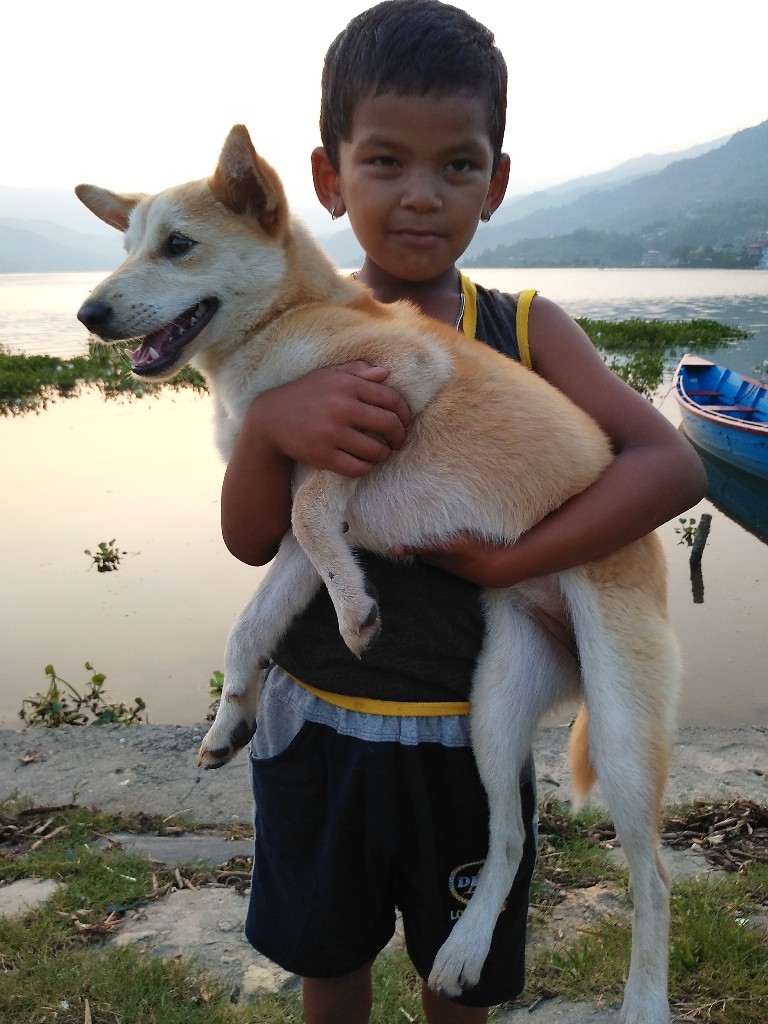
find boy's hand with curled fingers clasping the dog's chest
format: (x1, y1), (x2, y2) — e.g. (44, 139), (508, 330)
(257, 361), (412, 477)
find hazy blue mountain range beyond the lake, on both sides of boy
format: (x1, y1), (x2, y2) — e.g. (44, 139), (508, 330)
(0, 121), (768, 273)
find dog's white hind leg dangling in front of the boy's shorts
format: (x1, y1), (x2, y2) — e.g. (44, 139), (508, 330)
(429, 590), (579, 996)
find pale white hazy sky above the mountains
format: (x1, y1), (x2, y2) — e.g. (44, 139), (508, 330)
(7, 0), (768, 207)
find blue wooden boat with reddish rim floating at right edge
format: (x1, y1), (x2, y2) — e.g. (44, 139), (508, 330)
(675, 355), (768, 478)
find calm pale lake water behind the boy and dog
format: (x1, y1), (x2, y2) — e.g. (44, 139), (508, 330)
(0, 269), (768, 727)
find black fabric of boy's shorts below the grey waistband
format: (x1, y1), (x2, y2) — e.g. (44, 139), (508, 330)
(246, 722), (536, 1007)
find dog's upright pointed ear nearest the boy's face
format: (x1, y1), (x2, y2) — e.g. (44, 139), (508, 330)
(208, 125), (288, 236)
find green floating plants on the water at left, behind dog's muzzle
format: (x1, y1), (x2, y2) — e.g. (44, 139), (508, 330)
(0, 342), (207, 416)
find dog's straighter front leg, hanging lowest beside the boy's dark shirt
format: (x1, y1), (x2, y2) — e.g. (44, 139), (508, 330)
(198, 532), (321, 768)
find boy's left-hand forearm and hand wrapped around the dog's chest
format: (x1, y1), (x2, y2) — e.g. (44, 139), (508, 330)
(221, 362), (411, 565)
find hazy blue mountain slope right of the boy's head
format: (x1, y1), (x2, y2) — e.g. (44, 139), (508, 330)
(465, 121), (768, 266)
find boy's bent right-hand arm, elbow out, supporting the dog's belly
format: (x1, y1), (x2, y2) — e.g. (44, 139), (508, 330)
(403, 298), (707, 587)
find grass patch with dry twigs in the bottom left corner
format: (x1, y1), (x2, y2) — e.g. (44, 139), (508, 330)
(0, 804), (237, 1024)
